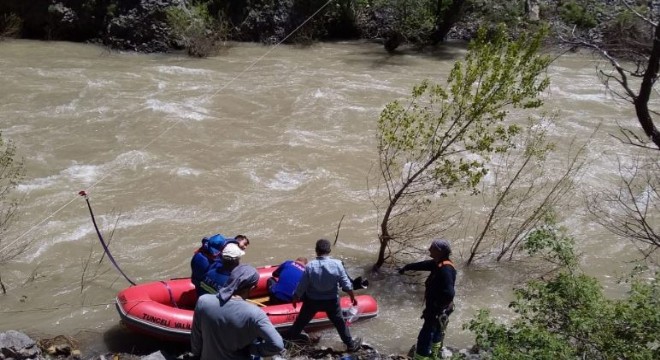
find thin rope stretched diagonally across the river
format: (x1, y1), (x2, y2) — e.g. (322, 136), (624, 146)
(0, 0), (334, 272)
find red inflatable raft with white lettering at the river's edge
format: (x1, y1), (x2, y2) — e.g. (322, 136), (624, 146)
(116, 266), (378, 342)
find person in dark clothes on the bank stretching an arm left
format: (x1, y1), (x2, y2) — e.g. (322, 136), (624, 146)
(399, 239), (456, 360)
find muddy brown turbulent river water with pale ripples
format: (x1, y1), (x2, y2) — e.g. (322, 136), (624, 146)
(0, 41), (652, 353)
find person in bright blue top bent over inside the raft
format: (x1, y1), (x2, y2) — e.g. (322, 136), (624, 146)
(267, 257), (307, 304)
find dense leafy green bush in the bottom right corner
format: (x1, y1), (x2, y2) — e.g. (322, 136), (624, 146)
(465, 221), (660, 360)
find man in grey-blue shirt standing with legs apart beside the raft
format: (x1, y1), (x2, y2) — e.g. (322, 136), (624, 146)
(286, 239), (362, 351)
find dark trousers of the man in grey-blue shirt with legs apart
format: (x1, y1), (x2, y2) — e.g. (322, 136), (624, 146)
(286, 297), (353, 346)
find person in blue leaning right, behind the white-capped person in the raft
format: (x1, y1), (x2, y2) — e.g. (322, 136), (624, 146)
(190, 234), (250, 296)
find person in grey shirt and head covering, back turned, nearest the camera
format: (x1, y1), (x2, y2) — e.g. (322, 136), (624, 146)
(190, 265), (284, 360)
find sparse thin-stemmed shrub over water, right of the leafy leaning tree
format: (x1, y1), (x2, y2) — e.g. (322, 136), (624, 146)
(467, 118), (586, 265)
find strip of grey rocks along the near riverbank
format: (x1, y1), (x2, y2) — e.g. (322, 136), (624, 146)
(0, 330), (482, 360)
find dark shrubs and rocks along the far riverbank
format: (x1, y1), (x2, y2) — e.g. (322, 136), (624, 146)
(0, 0), (648, 57)
